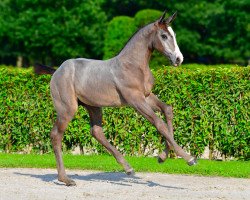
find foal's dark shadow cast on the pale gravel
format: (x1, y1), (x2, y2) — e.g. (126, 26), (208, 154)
(14, 172), (186, 190)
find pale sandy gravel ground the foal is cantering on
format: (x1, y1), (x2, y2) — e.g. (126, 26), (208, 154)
(0, 168), (250, 200)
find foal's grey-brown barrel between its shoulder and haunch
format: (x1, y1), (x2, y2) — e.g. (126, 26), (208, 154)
(74, 62), (123, 107)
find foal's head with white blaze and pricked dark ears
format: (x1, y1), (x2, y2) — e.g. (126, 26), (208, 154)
(153, 11), (183, 67)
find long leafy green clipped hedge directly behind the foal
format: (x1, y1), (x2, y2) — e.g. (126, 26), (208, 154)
(0, 67), (250, 160)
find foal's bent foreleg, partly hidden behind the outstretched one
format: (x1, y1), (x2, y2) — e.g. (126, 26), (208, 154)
(146, 93), (174, 163)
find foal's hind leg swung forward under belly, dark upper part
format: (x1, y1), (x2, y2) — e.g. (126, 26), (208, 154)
(85, 106), (134, 175)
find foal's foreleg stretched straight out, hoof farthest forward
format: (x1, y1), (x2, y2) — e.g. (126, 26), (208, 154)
(127, 92), (196, 165)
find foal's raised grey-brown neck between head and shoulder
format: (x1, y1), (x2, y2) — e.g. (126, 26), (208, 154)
(118, 25), (152, 68)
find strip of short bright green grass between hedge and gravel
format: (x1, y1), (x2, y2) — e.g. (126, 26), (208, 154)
(0, 153), (250, 178)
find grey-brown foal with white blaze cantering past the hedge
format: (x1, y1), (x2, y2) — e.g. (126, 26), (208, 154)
(50, 12), (196, 186)
